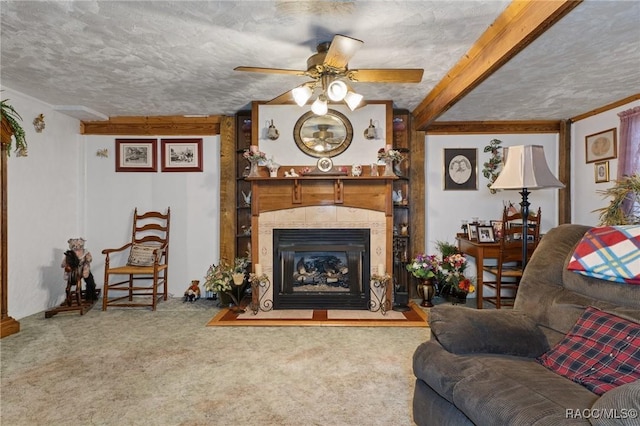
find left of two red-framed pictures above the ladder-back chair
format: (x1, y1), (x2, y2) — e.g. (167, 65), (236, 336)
(116, 139), (158, 172)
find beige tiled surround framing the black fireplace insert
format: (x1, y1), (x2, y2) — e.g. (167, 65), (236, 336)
(257, 205), (387, 308)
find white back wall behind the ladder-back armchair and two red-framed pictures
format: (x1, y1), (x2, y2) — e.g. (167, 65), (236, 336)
(82, 135), (220, 297)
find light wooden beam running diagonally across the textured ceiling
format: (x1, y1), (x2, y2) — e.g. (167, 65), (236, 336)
(413, 0), (582, 131)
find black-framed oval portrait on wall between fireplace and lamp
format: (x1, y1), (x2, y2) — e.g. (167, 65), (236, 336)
(442, 148), (478, 191)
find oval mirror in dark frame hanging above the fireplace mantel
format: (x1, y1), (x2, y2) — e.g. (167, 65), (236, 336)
(293, 109), (353, 158)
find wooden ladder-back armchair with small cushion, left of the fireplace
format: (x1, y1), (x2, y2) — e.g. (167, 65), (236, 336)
(102, 208), (171, 311)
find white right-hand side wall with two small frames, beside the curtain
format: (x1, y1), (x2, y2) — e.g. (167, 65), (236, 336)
(571, 101), (640, 226)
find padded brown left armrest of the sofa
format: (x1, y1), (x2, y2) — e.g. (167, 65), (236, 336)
(429, 305), (549, 358)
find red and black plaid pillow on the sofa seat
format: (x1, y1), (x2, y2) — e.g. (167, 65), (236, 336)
(537, 306), (640, 395)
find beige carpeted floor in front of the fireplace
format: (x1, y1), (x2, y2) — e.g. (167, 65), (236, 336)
(0, 299), (429, 425)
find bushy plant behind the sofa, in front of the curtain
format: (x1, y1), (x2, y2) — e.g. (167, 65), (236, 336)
(594, 173), (640, 226)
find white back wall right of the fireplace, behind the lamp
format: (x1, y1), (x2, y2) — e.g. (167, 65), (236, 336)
(424, 134), (558, 296)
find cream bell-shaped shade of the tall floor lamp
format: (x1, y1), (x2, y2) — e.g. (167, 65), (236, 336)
(491, 145), (564, 189)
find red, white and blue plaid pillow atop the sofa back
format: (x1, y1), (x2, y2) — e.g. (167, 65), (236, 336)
(567, 225), (640, 284)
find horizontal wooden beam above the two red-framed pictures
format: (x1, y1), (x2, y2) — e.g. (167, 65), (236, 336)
(80, 115), (223, 136)
